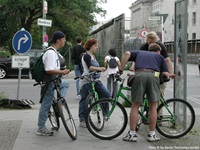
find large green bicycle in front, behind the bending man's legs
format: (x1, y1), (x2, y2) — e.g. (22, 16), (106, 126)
(86, 75), (195, 140)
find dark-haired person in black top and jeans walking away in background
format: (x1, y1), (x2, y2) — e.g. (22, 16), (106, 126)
(71, 37), (85, 100)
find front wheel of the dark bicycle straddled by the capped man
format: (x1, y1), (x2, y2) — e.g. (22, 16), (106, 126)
(58, 98), (77, 140)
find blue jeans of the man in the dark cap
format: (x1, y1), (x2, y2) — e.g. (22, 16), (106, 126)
(38, 80), (69, 129)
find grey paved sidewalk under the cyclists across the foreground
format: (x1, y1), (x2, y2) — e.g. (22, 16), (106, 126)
(0, 104), (200, 150)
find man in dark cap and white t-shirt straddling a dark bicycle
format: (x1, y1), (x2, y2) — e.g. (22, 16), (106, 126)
(36, 31), (70, 136)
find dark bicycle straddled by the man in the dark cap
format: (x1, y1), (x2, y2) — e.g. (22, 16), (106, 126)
(34, 75), (77, 140)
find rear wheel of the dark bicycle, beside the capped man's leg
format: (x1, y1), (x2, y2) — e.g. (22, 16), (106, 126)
(48, 102), (60, 130)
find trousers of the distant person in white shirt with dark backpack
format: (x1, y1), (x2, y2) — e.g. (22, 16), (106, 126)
(107, 74), (118, 97)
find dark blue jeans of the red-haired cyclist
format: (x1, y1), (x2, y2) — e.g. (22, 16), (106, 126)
(79, 81), (110, 122)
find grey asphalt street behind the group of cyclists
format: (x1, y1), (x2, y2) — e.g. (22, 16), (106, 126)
(0, 64), (200, 108)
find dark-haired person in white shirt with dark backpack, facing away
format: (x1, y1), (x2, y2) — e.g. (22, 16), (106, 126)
(104, 48), (121, 97)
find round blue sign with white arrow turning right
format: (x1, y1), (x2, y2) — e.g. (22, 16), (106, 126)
(12, 28), (32, 54)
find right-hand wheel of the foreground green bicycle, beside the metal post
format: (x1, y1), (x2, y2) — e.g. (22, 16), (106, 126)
(156, 98), (195, 138)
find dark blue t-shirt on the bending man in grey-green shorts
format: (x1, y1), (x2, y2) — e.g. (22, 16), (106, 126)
(129, 51), (169, 72)
